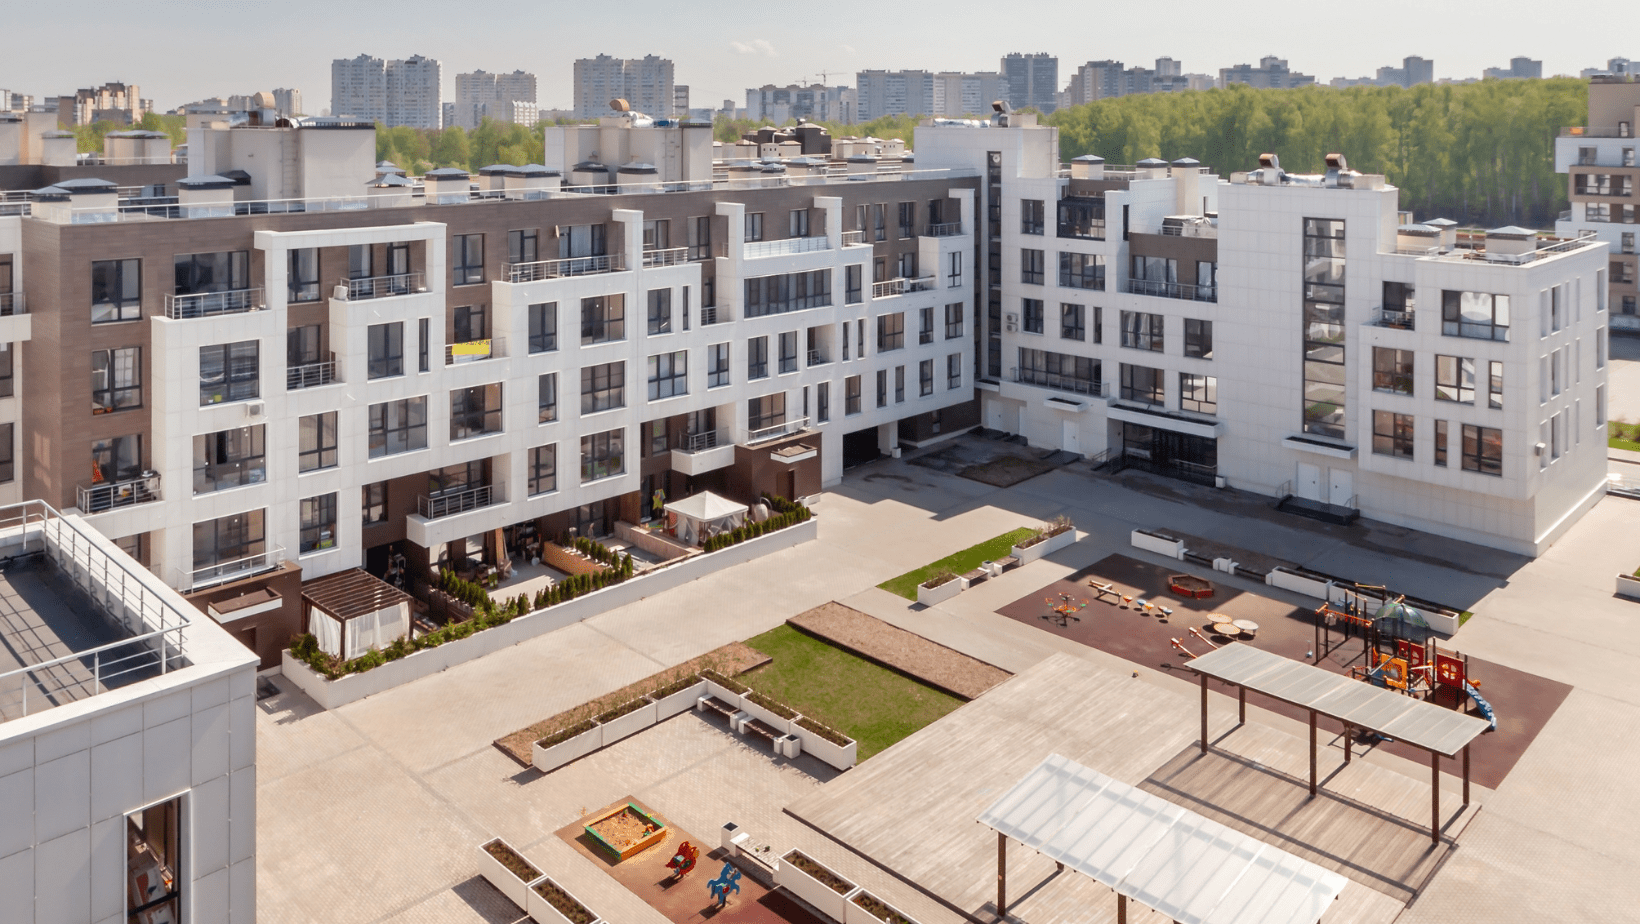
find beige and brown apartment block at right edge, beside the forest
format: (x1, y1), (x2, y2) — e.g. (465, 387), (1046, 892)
(1555, 75), (1640, 330)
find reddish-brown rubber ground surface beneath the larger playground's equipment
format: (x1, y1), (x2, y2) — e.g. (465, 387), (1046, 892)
(997, 555), (1571, 789)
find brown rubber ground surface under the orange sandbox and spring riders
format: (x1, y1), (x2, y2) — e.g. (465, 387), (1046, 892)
(554, 796), (827, 924)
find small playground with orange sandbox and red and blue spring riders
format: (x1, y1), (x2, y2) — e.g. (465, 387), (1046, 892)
(554, 796), (827, 924)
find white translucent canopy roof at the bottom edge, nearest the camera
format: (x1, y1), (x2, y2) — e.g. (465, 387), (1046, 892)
(977, 755), (1346, 924)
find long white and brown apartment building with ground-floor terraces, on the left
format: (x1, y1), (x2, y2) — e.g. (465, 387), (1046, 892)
(0, 113), (977, 666)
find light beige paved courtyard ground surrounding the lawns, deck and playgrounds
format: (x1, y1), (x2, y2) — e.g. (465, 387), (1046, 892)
(257, 416), (1640, 924)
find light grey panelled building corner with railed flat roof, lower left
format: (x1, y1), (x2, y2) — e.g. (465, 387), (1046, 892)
(0, 501), (256, 924)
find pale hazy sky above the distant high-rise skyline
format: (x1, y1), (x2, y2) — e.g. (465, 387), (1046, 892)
(0, 0), (1640, 115)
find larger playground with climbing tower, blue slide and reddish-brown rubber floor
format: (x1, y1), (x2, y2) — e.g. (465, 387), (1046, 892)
(997, 555), (1571, 788)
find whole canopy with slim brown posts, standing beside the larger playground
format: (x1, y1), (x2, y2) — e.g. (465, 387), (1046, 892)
(1186, 642), (1489, 844)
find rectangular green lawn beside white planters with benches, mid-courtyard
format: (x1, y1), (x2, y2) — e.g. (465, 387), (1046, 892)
(738, 625), (963, 760)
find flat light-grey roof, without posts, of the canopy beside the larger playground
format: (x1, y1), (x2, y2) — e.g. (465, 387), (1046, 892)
(1186, 642), (1491, 757)
